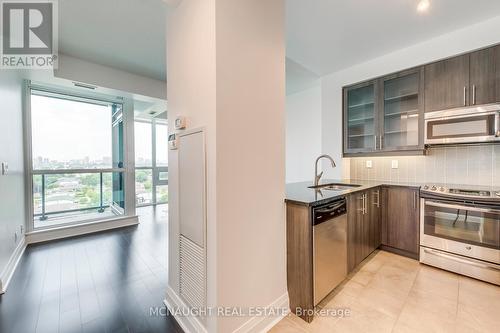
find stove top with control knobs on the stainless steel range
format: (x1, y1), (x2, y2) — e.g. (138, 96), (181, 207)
(421, 184), (500, 200)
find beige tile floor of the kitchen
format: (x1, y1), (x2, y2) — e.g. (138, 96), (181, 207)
(270, 251), (500, 333)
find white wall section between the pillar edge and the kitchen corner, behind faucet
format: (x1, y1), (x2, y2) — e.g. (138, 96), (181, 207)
(286, 82), (322, 183)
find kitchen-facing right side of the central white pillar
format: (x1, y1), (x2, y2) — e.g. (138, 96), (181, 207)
(216, 0), (287, 332)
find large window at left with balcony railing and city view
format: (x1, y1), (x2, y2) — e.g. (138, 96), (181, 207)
(30, 89), (124, 228)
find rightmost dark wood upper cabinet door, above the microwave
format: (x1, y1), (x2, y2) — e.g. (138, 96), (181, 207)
(469, 46), (500, 105)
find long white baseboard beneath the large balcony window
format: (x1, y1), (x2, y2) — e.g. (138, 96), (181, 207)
(26, 216), (139, 244)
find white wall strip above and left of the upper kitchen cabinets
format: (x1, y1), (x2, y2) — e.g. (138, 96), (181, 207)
(322, 16), (500, 178)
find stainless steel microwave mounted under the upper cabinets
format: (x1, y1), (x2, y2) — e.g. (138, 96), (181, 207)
(424, 104), (500, 145)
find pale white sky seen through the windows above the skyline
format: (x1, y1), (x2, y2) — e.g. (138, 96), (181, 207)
(31, 95), (168, 165)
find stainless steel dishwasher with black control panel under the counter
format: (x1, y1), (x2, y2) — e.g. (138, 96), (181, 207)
(313, 198), (347, 306)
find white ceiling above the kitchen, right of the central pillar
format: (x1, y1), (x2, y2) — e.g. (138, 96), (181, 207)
(286, 0), (500, 75)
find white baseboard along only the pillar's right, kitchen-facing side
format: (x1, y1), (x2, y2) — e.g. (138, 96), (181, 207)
(233, 292), (290, 333)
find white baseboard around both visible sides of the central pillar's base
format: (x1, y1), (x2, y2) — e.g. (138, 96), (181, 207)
(164, 286), (290, 333)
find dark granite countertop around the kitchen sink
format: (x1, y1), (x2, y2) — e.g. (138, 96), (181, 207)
(285, 179), (423, 206)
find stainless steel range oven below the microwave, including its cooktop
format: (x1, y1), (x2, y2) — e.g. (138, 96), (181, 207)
(420, 186), (500, 285)
